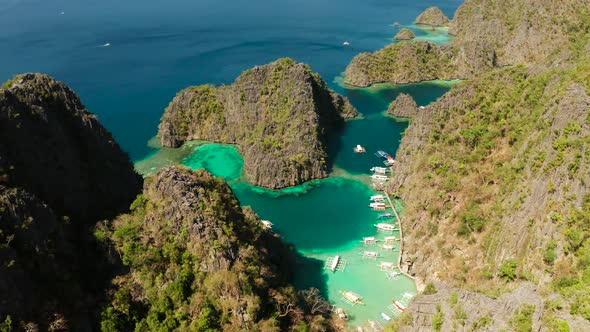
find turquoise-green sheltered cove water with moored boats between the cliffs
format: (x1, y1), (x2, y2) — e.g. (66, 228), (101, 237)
(136, 80), (452, 326)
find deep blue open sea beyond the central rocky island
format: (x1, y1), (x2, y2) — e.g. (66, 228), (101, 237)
(0, 0), (461, 160)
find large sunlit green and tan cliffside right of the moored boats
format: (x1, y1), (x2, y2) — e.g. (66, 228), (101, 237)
(389, 59), (590, 330)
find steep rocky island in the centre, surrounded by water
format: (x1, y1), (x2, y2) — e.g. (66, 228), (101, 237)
(158, 59), (357, 189)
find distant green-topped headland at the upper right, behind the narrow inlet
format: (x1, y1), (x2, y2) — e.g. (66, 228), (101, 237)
(345, 0), (590, 86)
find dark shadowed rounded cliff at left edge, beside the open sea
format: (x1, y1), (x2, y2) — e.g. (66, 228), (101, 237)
(0, 74), (141, 223)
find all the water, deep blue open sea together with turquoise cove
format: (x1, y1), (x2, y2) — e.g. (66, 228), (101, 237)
(0, 0), (462, 325)
